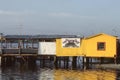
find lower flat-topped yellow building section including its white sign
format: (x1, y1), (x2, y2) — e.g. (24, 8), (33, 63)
(56, 38), (83, 56)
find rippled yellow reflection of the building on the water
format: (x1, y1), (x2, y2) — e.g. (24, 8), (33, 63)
(55, 70), (116, 80)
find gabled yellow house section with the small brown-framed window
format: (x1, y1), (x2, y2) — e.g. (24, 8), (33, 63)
(83, 33), (116, 57)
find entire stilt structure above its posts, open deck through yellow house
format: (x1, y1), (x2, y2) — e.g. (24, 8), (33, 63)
(1, 33), (117, 57)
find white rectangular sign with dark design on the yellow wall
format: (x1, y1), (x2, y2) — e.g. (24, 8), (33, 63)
(62, 38), (80, 48)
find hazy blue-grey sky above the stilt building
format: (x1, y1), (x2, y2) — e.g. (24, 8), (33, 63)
(0, 0), (120, 35)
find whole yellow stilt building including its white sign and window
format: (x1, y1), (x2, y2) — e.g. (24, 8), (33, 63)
(56, 33), (116, 57)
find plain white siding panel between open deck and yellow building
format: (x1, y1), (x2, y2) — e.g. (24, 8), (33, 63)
(38, 42), (56, 55)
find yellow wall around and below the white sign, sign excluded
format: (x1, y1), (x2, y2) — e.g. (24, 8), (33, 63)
(56, 39), (83, 56)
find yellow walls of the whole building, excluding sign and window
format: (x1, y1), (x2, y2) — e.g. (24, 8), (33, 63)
(56, 34), (116, 57)
